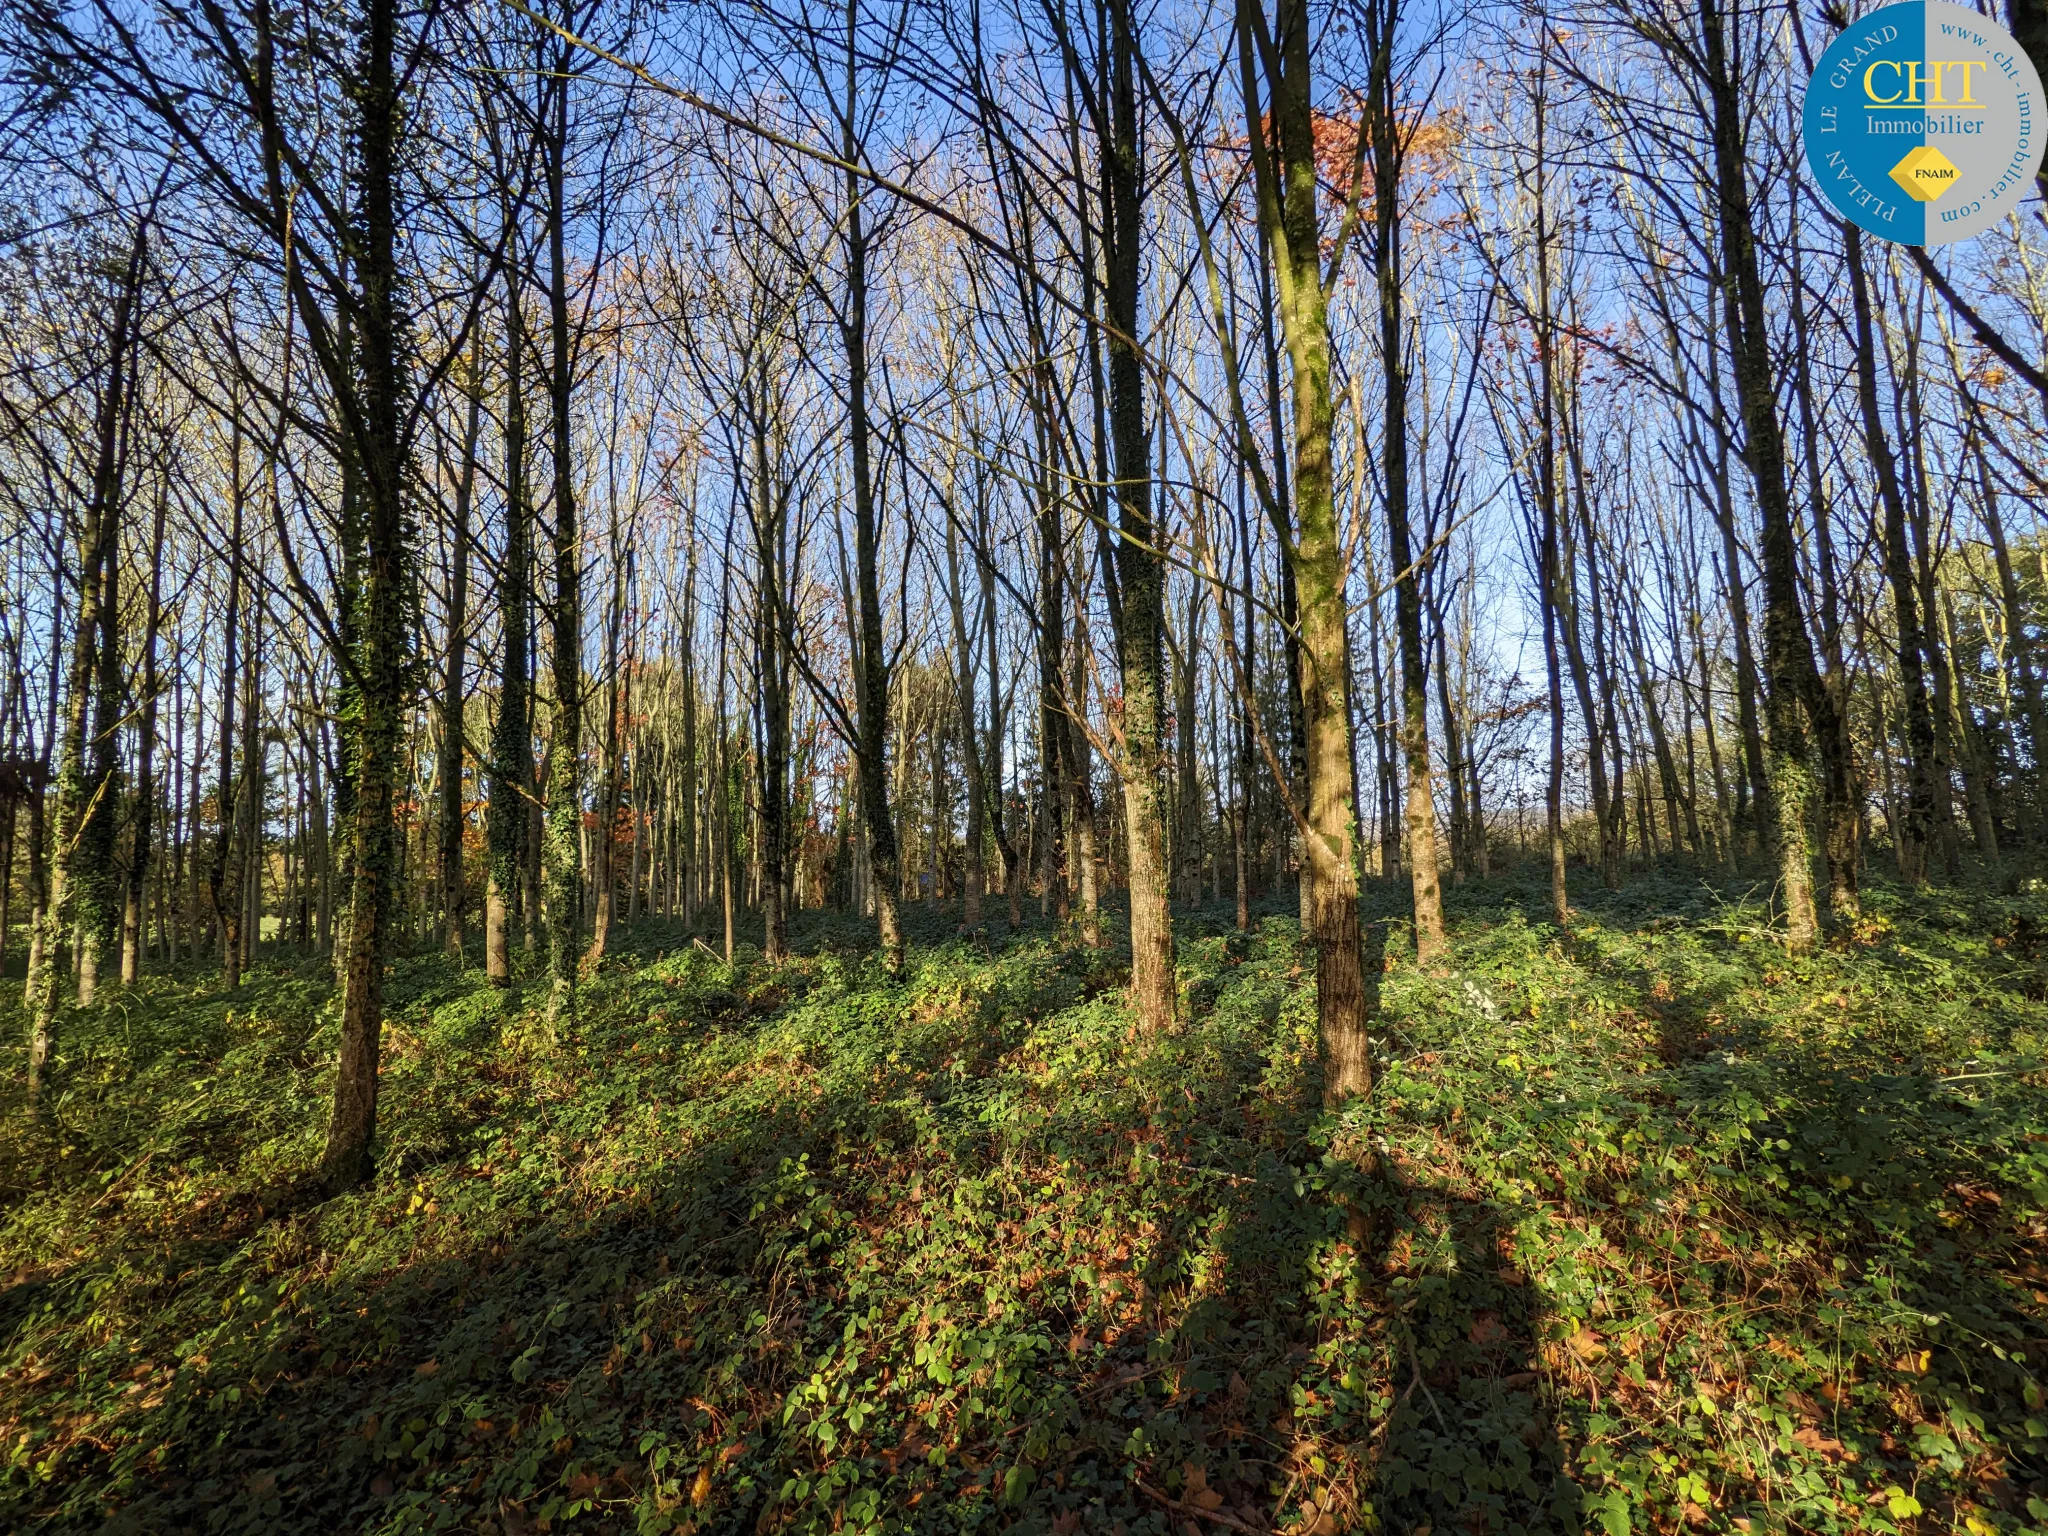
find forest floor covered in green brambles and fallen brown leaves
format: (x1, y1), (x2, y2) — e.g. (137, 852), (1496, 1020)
(0, 868), (2048, 1536)
